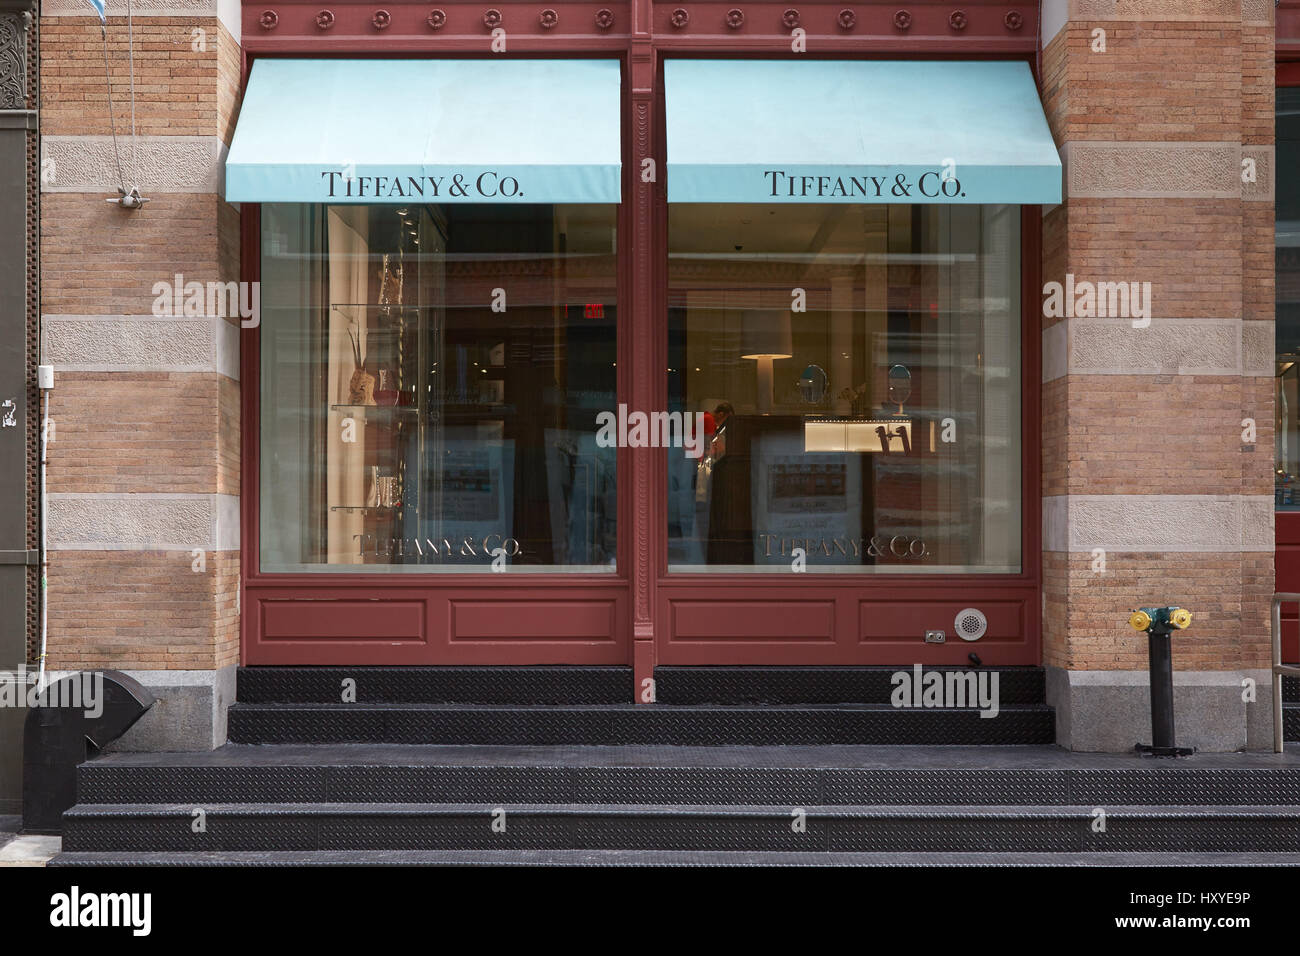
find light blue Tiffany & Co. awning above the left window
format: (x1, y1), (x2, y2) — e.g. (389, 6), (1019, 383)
(226, 60), (621, 203)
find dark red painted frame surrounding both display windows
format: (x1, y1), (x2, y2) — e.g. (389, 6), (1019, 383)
(241, 0), (1043, 684)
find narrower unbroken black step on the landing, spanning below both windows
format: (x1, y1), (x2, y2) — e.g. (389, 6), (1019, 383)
(229, 704), (1056, 745)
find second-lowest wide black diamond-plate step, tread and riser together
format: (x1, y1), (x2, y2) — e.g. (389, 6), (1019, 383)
(62, 804), (1300, 853)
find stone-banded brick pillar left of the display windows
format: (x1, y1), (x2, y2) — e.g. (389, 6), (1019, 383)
(40, 5), (242, 671)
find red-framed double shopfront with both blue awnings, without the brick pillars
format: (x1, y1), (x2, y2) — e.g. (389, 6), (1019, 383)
(228, 46), (1060, 679)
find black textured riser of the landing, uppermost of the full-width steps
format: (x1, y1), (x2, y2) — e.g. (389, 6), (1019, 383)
(78, 763), (1300, 806)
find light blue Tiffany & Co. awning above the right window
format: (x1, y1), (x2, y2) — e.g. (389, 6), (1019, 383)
(664, 60), (1061, 204)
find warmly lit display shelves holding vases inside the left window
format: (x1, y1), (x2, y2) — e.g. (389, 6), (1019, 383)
(324, 207), (446, 564)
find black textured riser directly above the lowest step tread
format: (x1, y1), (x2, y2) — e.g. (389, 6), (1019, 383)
(64, 809), (1300, 852)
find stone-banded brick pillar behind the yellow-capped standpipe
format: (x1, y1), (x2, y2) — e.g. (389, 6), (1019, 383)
(1043, 0), (1273, 671)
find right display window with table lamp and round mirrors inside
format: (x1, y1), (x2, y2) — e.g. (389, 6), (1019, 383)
(667, 203), (1023, 574)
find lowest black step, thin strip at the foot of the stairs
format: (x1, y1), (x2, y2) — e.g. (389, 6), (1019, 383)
(49, 849), (1300, 868)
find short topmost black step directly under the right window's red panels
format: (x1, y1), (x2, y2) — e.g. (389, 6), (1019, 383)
(654, 666), (1047, 704)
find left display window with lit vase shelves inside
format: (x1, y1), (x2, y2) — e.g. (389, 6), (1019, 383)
(260, 203), (618, 572)
